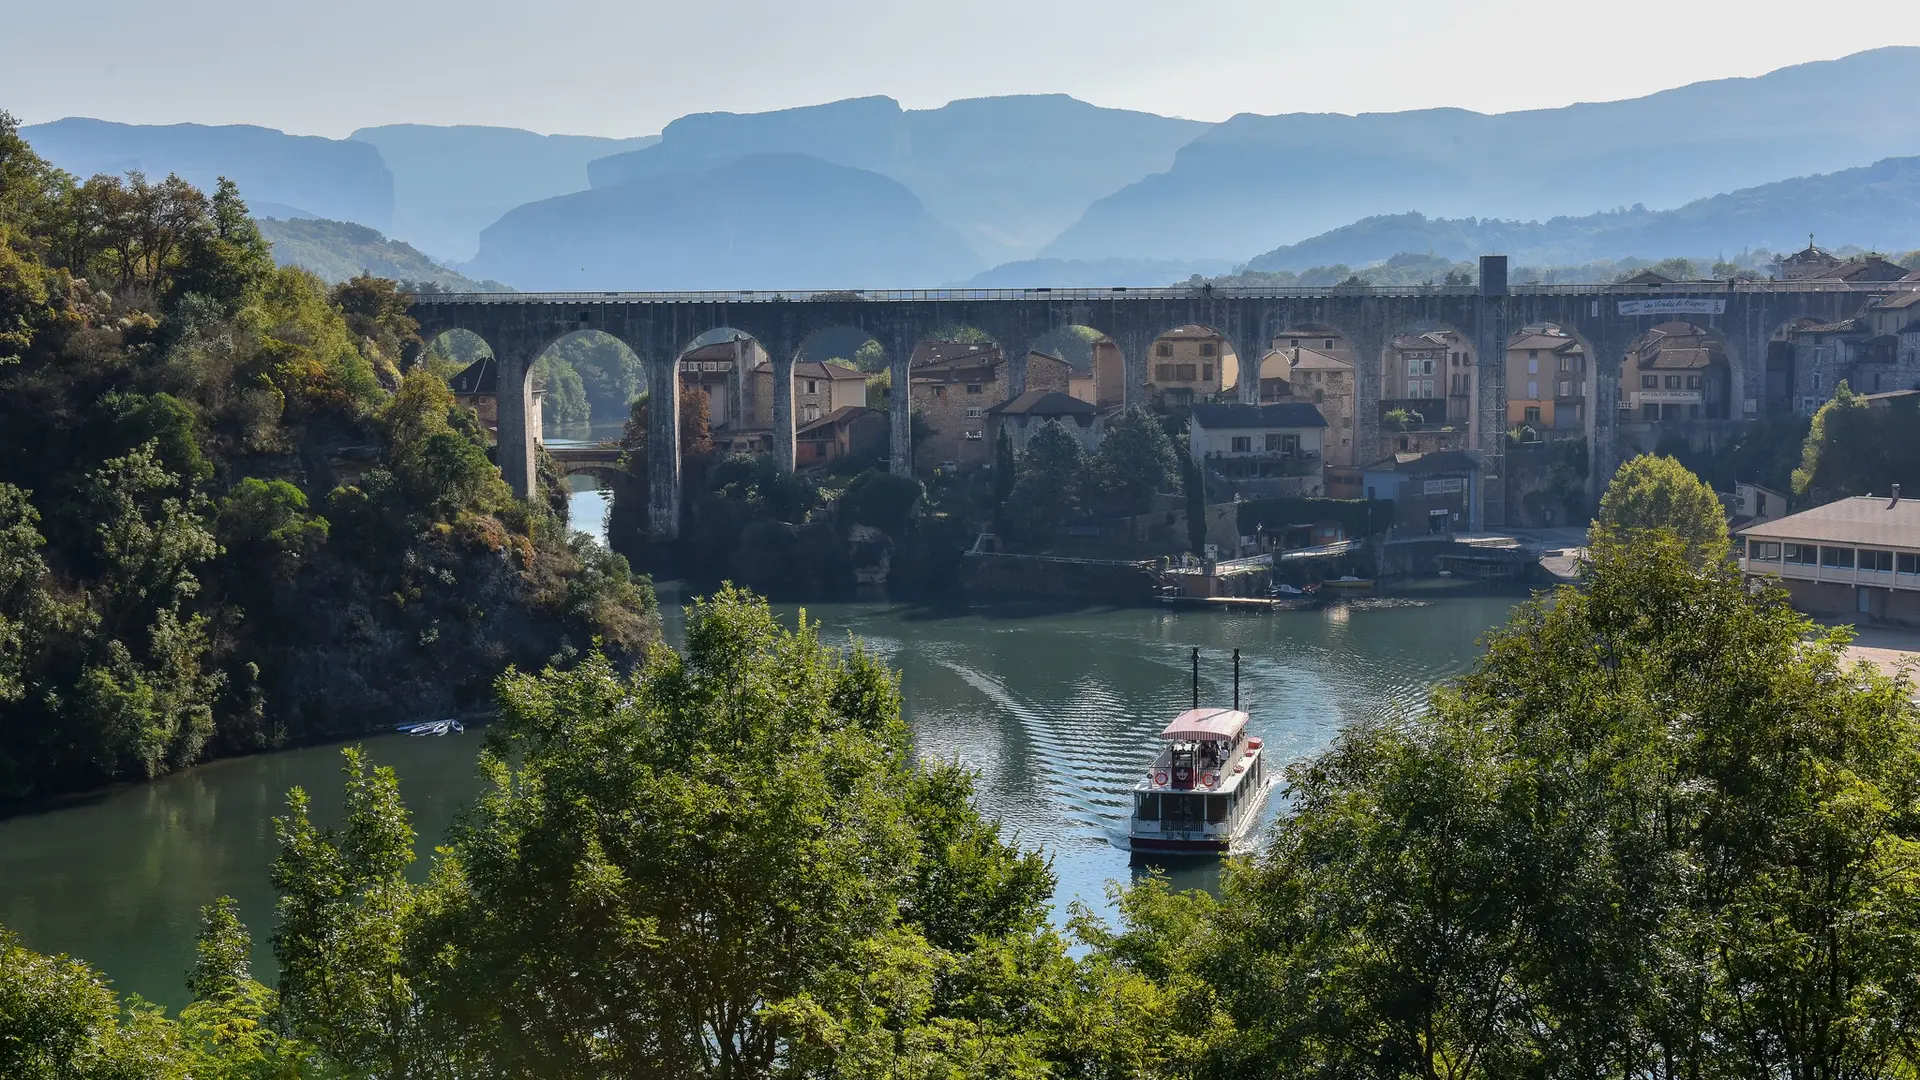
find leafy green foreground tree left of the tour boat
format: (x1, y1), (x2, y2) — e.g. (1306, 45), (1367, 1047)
(259, 588), (1073, 1080)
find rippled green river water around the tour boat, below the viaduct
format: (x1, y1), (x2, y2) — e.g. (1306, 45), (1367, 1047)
(0, 484), (1517, 1007)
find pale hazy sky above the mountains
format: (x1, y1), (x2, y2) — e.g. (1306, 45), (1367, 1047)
(11, 0), (1920, 136)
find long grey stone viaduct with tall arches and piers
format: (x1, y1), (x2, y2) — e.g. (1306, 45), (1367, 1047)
(409, 256), (1920, 540)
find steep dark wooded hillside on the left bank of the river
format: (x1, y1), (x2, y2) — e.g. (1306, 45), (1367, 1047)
(0, 113), (655, 798)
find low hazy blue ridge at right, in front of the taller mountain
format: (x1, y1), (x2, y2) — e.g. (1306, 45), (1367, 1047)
(1246, 158), (1920, 271)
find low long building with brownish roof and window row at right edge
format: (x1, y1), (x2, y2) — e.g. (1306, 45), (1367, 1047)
(1736, 484), (1920, 625)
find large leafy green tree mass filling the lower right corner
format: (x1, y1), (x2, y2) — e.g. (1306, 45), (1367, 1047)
(1136, 528), (1920, 1078)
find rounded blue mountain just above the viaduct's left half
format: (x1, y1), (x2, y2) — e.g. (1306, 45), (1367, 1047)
(463, 154), (979, 290)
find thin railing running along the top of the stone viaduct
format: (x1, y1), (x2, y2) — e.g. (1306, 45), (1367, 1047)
(413, 281), (1920, 306)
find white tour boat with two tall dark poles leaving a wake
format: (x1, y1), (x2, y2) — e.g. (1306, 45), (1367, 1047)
(1127, 650), (1275, 855)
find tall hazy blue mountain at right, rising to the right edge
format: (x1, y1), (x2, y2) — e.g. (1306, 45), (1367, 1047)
(1043, 48), (1920, 259)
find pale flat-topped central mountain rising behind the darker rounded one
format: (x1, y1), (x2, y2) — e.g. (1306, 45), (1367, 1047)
(588, 94), (1206, 263)
